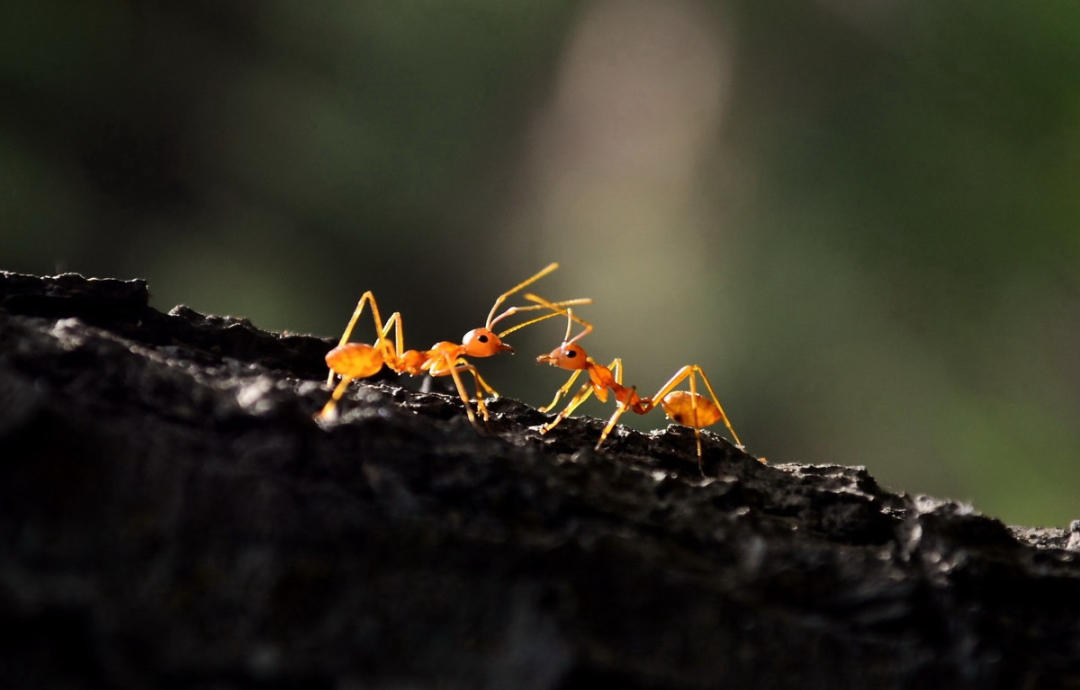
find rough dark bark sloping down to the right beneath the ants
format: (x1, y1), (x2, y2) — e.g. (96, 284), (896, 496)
(0, 273), (1080, 690)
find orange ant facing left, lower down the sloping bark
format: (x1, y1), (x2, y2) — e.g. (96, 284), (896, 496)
(525, 294), (744, 471)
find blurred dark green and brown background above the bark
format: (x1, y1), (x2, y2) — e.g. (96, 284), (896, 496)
(0, 0), (1080, 526)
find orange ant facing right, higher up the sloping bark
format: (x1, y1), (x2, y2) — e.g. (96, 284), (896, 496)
(316, 263), (592, 429)
